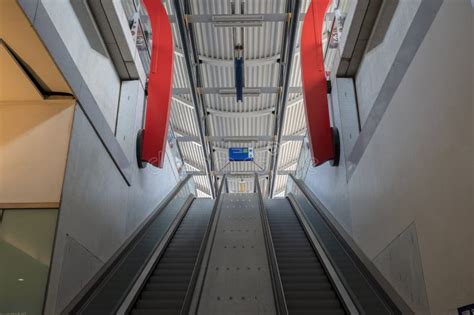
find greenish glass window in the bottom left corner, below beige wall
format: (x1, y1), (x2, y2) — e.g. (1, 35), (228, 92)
(0, 209), (58, 315)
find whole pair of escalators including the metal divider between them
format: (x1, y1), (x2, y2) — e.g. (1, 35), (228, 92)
(72, 176), (412, 315)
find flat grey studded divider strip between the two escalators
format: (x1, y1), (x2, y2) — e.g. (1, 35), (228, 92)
(198, 194), (276, 315)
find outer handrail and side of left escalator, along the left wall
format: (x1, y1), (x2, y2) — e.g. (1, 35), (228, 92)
(67, 175), (193, 314)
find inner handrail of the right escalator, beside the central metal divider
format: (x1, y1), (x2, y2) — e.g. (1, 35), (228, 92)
(255, 174), (288, 315)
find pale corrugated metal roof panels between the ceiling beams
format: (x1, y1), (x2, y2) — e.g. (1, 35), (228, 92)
(164, 0), (309, 196)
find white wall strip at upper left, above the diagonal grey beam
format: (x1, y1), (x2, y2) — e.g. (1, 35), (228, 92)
(41, 0), (120, 131)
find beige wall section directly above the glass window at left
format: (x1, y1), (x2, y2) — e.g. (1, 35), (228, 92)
(0, 100), (75, 207)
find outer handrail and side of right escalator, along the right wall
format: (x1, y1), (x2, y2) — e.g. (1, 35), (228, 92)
(289, 174), (414, 314)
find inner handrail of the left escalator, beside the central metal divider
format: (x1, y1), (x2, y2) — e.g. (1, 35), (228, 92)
(180, 175), (226, 315)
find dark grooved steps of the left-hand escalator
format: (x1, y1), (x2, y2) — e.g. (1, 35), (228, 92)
(131, 199), (212, 314)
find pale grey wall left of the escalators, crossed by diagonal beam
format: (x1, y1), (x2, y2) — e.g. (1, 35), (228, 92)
(45, 81), (179, 314)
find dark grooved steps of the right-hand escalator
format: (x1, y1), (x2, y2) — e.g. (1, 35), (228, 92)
(265, 199), (346, 315)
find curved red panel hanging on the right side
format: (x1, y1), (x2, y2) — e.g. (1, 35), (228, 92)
(301, 0), (335, 165)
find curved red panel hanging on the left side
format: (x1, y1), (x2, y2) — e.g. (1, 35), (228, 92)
(142, 0), (174, 167)
